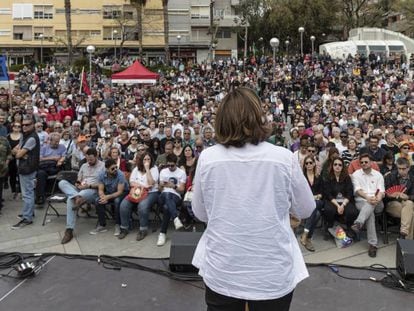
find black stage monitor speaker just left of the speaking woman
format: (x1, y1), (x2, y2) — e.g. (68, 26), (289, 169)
(170, 232), (203, 272)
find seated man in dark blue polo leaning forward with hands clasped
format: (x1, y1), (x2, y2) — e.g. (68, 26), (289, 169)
(89, 158), (129, 236)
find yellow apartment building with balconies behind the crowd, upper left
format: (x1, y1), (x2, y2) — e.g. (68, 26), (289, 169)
(0, 0), (165, 64)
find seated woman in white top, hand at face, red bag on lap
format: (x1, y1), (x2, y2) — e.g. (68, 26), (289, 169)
(118, 152), (159, 241)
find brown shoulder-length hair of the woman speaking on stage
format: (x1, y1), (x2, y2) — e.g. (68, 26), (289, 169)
(215, 87), (271, 147)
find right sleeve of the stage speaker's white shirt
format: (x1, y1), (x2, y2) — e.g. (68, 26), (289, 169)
(290, 157), (316, 219)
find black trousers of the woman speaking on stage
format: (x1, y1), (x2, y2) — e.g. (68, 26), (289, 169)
(205, 286), (293, 311)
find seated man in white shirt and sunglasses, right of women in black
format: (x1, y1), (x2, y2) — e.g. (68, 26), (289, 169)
(352, 154), (385, 257)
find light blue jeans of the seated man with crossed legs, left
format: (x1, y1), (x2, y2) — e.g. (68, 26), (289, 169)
(58, 180), (98, 229)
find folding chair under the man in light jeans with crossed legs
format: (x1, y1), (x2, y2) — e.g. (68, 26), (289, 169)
(42, 171), (78, 226)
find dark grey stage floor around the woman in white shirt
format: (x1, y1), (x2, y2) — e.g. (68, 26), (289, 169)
(0, 257), (414, 311)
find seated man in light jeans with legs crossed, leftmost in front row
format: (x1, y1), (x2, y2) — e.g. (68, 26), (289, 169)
(59, 148), (105, 244)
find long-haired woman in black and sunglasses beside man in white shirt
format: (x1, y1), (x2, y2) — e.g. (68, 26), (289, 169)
(323, 156), (358, 240)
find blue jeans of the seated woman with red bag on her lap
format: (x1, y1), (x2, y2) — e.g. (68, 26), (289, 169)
(120, 191), (159, 231)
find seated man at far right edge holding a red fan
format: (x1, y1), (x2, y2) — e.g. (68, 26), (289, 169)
(385, 158), (414, 240)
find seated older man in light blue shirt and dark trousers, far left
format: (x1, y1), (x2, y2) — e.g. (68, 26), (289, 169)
(36, 133), (66, 204)
